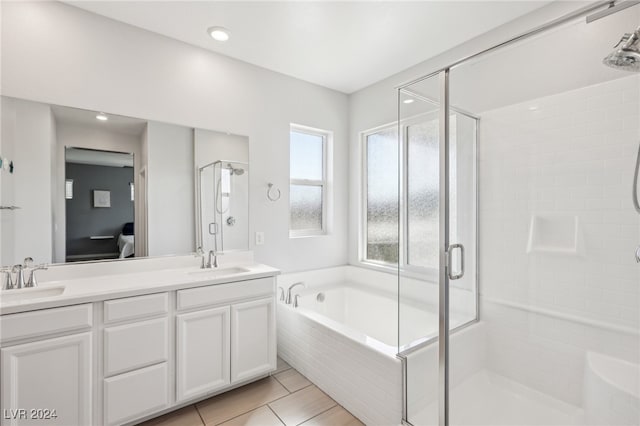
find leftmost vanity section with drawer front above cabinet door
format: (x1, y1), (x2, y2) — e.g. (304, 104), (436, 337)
(0, 304), (94, 426)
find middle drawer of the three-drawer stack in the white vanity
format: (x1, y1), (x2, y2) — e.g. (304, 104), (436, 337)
(104, 318), (169, 377)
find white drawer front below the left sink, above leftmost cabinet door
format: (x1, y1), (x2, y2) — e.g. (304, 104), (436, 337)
(0, 304), (93, 343)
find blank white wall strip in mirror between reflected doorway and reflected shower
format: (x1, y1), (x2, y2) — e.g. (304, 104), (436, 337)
(147, 121), (195, 256)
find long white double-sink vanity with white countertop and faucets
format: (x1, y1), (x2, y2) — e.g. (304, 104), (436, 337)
(0, 259), (278, 426)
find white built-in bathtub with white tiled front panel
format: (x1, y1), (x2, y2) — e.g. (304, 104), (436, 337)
(277, 266), (478, 425)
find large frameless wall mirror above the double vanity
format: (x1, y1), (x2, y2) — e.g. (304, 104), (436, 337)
(0, 97), (249, 265)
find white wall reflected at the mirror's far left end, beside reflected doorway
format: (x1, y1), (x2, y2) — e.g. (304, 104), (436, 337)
(0, 97), (55, 265)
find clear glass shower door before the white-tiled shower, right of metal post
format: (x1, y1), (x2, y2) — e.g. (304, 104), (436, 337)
(444, 6), (640, 426)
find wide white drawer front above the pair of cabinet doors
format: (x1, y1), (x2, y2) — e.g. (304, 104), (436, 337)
(178, 277), (275, 310)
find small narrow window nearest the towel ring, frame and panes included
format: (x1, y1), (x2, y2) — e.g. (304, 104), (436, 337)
(289, 125), (331, 237)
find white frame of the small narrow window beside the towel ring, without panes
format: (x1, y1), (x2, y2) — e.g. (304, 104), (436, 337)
(289, 123), (333, 238)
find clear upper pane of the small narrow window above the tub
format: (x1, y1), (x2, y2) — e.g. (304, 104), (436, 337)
(290, 131), (324, 180)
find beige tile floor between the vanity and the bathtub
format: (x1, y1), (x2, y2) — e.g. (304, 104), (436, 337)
(140, 358), (362, 426)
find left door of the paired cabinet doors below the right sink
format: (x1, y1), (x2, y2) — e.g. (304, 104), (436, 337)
(176, 306), (230, 401)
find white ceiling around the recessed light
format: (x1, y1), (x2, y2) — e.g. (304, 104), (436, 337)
(67, 0), (551, 93)
